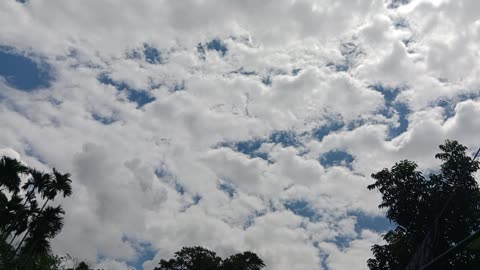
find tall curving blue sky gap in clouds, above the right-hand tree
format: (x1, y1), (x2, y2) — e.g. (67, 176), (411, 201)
(370, 85), (411, 138)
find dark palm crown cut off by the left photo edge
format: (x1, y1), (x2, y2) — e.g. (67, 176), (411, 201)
(0, 156), (28, 193)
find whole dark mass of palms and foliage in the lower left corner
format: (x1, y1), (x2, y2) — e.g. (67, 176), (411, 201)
(0, 157), (72, 270)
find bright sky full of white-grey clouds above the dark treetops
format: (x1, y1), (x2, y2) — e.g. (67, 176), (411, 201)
(0, 0), (480, 270)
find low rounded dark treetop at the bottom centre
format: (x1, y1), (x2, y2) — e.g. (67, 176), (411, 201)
(154, 246), (265, 270)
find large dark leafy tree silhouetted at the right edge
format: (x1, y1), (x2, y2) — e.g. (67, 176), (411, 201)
(368, 140), (480, 270)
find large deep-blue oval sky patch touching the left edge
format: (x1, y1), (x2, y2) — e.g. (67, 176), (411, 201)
(0, 46), (54, 91)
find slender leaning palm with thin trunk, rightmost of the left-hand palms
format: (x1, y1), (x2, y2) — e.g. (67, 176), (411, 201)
(15, 168), (72, 253)
